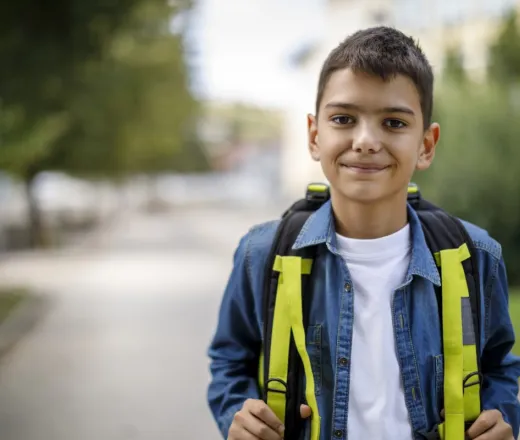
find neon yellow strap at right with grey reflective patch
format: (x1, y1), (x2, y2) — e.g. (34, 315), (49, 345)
(435, 244), (480, 440)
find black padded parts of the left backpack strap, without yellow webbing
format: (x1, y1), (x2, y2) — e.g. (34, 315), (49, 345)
(262, 184), (329, 439)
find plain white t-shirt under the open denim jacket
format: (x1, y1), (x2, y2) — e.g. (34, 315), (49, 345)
(337, 225), (413, 440)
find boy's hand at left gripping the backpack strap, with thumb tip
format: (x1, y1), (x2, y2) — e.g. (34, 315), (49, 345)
(228, 399), (311, 440)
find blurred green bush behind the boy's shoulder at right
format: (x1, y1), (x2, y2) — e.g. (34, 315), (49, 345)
(416, 10), (520, 284)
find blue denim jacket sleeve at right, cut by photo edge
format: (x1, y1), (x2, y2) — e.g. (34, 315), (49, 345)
(481, 254), (520, 438)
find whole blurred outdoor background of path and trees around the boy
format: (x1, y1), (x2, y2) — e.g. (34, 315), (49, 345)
(0, 0), (520, 440)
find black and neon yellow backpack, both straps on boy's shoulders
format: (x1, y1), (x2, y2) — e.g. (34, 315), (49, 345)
(259, 183), (482, 440)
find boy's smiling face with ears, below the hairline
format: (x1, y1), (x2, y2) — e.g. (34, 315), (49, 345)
(308, 69), (440, 203)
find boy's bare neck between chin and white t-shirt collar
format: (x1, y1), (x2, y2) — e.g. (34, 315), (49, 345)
(332, 191), (408, 239)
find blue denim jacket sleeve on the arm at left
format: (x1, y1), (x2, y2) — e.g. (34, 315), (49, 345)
(208, 232), (261, 438)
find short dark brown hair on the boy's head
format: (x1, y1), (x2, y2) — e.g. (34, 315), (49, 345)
(316, 26), (433, 130)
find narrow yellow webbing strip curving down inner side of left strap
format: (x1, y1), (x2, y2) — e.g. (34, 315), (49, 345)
(282, 257), (320, 440)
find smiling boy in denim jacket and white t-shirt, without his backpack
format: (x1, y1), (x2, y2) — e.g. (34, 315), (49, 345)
(208, 27), (520, 440)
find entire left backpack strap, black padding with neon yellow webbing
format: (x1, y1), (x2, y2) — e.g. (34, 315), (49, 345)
(258, 183), (330, 440)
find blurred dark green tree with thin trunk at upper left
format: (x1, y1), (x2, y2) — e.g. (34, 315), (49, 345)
(0, 0), (207, 244)
